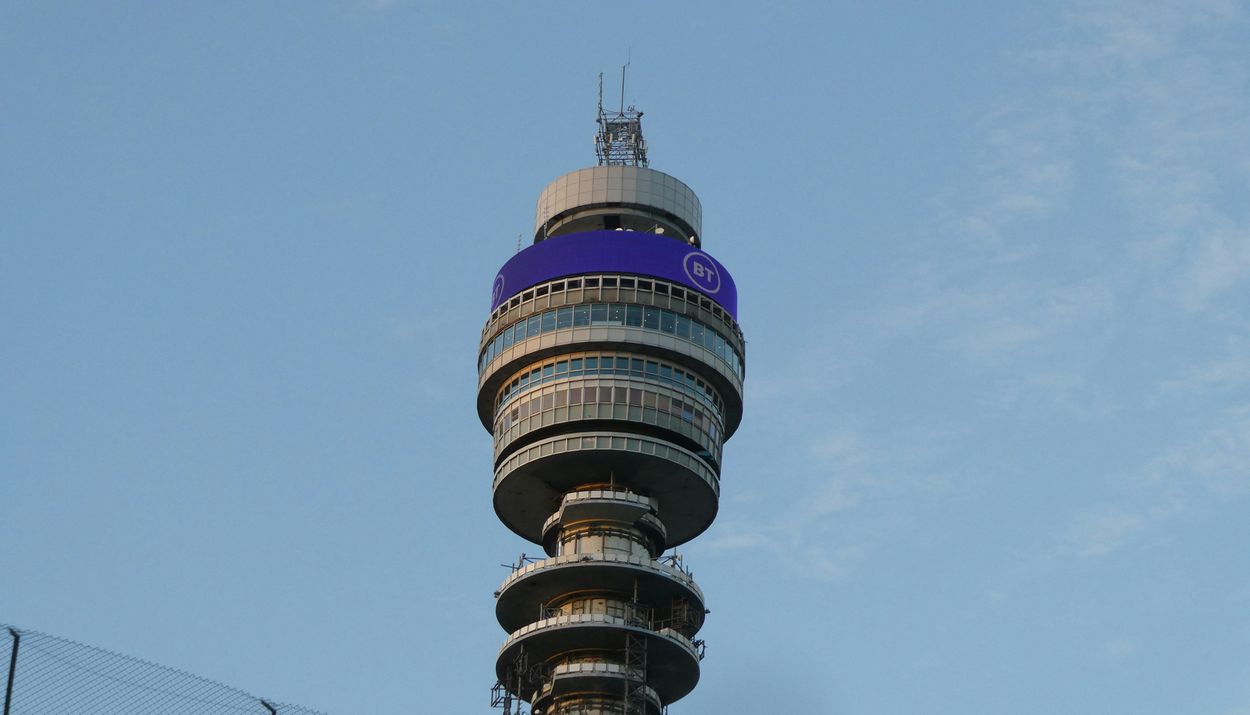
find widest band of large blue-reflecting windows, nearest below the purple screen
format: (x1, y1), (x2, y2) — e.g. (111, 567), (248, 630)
(478, 303), (743, 379)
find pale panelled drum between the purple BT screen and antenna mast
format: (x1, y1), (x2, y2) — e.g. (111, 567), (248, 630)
(534, 165), (703, 246)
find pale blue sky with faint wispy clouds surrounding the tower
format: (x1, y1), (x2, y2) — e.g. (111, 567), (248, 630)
(0, 0), (1250, 715)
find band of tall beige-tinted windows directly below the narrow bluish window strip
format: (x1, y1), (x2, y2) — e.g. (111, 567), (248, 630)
(495, 380), (720, 460)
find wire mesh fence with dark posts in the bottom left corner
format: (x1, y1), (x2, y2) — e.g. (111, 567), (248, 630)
(0, 624), (324, 715)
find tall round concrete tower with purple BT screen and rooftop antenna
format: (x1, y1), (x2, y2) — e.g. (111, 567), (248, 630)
(478, 85), (745, 715)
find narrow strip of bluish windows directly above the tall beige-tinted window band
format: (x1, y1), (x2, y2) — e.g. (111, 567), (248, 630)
(495, 353), (723, 415)
